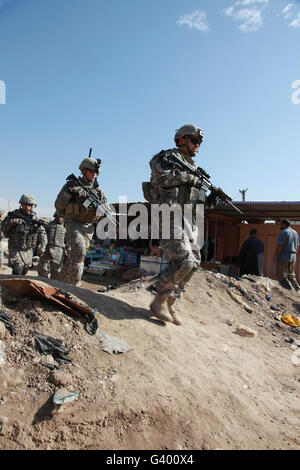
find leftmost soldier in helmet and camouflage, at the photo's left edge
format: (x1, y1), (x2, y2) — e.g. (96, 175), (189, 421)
(1, 194), (47, 276)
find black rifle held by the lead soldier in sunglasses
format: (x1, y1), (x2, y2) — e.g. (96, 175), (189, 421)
(163, 152), (243, 214)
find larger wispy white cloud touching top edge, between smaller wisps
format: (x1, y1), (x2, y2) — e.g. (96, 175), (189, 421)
(222, 0), (269, 33)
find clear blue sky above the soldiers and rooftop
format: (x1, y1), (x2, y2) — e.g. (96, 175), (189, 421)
(0, 0), (300, 216)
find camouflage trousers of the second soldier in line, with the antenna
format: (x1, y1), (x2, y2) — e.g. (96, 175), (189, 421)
(59, 221), (94, 285)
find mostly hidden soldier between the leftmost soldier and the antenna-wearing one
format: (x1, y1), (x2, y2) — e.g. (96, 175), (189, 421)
(37, 212), (66, 279)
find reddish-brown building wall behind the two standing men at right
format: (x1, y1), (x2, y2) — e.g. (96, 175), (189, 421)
(239, 224), (300, 282)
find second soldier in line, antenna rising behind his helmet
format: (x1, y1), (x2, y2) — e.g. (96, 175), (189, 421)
(55, 158), (106, 285)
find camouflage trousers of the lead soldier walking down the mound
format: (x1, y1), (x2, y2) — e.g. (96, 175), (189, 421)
(156, 229), (201, 298)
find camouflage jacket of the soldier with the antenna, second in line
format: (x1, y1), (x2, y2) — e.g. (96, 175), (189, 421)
(55, 177), (106, 225)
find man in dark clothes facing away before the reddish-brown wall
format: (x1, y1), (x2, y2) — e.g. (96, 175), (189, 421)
(238, 229), (264, 276)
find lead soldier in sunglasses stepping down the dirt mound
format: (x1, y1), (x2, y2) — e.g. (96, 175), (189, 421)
(143, 124), (206, 325)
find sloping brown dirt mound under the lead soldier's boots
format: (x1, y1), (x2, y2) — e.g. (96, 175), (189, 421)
(0, 270), (300, 449)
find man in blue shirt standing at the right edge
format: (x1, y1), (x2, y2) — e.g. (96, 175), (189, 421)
(273, 219), (300, 292)
